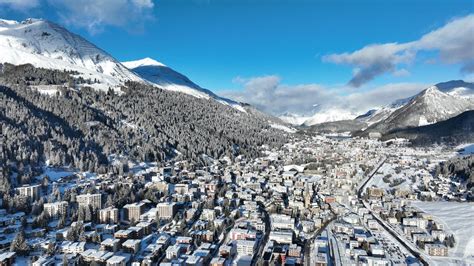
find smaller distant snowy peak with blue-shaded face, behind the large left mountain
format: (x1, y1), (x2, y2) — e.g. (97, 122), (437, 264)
(122, 58), (245, 112)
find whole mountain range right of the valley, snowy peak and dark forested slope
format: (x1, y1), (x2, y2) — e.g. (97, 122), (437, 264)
(310, 80), (474, 143)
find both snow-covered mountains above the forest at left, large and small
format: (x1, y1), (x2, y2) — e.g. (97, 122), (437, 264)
(0, 19), (250, 112)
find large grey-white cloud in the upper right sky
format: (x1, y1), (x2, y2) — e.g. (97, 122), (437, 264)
(323, 15), (474, 87)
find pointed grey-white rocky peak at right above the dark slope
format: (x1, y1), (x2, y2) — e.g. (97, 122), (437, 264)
(367, 86), (474, 133)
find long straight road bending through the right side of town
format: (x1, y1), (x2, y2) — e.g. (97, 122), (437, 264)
(357, 157), (428, 266)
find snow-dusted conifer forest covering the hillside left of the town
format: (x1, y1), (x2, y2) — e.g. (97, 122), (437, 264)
(0, 64), (285, 176)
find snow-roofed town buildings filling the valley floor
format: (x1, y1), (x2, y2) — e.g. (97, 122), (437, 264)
(0, 136), (464, 266)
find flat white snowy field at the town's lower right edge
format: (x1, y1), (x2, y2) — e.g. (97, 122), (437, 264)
(412, 202), (474, 265)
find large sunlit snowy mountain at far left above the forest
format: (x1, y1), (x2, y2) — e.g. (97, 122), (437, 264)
(0, 19), (142, 89)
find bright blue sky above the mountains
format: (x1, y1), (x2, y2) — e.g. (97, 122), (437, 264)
(0, 0), (474, 115)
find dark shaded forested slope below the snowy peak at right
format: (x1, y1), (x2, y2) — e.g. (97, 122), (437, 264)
(383, 110), (474, 145)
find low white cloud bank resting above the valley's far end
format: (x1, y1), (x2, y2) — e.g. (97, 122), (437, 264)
(221, 75), (429, 116)
